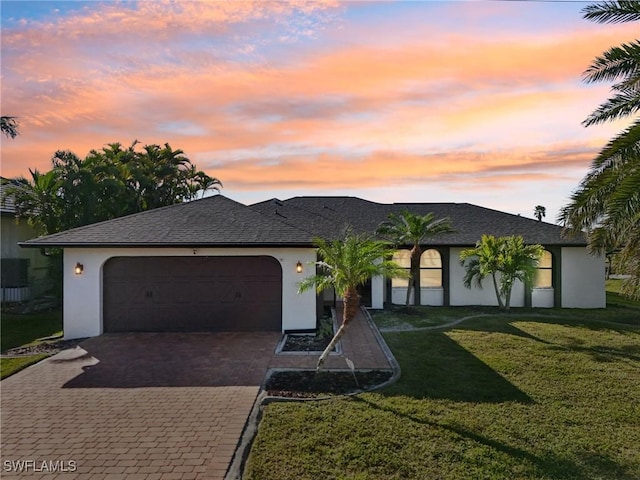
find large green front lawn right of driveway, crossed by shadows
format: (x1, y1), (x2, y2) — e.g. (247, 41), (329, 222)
(245, 307), (640, 480)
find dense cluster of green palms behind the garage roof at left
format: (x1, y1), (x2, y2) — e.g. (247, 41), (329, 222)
(3, 141), (222, 235)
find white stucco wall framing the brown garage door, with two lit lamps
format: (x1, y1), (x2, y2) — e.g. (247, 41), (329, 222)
(64, 248), (316, 339)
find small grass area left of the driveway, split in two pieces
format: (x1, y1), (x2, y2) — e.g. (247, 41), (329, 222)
(0, 310), (62, 379)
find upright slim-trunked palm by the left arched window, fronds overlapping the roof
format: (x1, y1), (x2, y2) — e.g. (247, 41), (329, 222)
(376, 210), (454, 305)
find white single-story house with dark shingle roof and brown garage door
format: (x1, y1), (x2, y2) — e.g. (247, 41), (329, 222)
(22, 195), (605, 338)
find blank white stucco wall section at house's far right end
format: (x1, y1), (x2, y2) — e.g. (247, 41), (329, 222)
(561, 247), (607, 308)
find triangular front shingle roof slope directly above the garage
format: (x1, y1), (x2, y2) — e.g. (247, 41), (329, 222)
(23, 195), (311, 247)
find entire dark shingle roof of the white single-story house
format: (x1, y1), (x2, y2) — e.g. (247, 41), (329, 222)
(22, 195), (586, 247)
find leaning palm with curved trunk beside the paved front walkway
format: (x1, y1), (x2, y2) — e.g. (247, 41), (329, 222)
(298, 232), (407, 370)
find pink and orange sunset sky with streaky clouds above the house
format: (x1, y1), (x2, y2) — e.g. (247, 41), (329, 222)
(1, 0), (638, 222)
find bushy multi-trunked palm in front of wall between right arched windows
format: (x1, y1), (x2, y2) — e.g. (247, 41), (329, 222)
(460, 235), (544, 311)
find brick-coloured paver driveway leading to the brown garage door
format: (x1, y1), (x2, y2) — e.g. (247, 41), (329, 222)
(0, 332), (280, 480)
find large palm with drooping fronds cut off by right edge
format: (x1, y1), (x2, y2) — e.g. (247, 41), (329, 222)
(559, 0), (640, 298)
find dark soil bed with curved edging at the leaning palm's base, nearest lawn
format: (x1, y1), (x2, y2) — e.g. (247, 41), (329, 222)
(265, 370), (392, 398)
